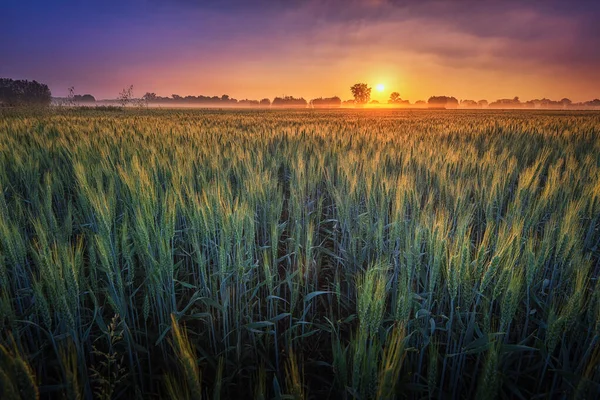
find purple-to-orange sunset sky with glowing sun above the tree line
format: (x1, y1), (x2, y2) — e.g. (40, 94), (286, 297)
(0, 0), (600, 102)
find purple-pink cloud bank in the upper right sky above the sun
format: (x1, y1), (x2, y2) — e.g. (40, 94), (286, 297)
(270, 0), (600, 68)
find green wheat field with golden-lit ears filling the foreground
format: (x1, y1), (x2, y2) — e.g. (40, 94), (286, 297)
(0, 110), (600, 399)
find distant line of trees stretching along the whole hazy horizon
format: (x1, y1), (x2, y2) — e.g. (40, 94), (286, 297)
(0, 78), (600, 109)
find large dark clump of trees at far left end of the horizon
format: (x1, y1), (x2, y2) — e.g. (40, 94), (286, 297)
(0, 78), (52, 106)
